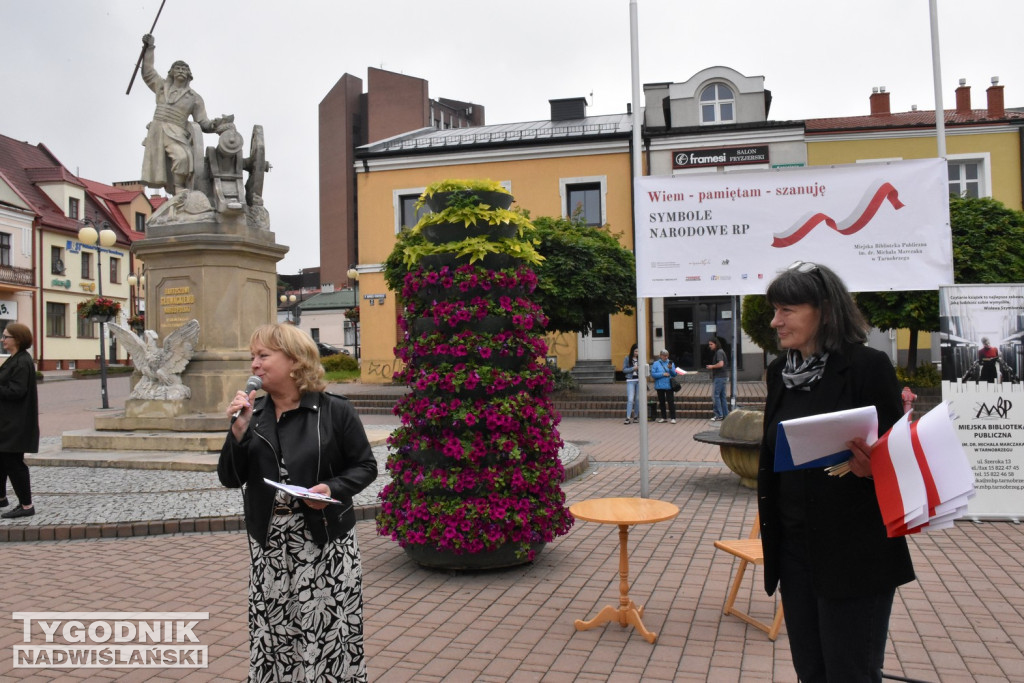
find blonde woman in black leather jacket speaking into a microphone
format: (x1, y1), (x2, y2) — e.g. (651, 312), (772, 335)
(217, 325), (377, 682)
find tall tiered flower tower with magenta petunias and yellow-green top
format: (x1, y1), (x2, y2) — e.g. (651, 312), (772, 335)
(378, 181), (572, 569)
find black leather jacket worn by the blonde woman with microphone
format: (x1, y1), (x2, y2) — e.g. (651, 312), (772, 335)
(217, 392), (377, 547)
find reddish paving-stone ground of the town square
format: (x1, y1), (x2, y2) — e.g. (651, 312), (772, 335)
(0, 376), (1024, 683)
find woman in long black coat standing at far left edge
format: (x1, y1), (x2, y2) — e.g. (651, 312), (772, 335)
(0, 323), (39, 519)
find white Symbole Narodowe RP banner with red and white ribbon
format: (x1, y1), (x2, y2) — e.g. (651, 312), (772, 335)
(635, 159), (952, 297)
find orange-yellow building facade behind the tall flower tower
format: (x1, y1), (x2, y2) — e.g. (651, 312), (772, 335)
(355, 117), (636, 383)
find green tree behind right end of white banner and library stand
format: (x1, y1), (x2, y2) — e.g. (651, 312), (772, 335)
(857, 197), (1024, 371)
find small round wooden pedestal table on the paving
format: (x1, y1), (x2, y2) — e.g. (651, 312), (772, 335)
(569, 498), (679, 643)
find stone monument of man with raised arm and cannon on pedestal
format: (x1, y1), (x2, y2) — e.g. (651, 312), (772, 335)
(121, 34), (288, 421)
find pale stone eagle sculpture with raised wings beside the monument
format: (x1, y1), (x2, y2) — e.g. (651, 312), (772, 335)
(106, 319), (199, 400)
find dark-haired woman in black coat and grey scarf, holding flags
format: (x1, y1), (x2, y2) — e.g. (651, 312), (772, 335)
(758, 261), (914, 683)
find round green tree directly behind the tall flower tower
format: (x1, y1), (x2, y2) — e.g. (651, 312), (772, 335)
(384, 210), (637, 334)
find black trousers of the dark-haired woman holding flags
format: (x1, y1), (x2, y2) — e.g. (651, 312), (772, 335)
(779, 540), (896, 683)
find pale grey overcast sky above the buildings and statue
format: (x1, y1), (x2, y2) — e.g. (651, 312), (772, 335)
(0, 0), (1024, 273)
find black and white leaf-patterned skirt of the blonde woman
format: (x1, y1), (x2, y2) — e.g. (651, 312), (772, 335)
(249, 514), (367, 683)
